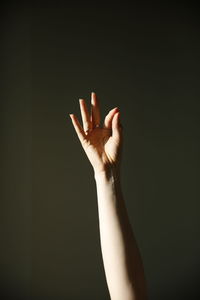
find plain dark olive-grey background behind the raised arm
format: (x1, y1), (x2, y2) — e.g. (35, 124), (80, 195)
(0, 1), (200, 300)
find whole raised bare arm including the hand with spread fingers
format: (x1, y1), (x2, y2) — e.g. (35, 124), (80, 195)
(70, 93), (147, 300)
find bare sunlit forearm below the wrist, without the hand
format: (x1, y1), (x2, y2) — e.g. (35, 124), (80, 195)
(95, 169), (146, 300)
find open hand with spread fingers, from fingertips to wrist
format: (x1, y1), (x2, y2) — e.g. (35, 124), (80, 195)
(70, 93), (122, 173)
